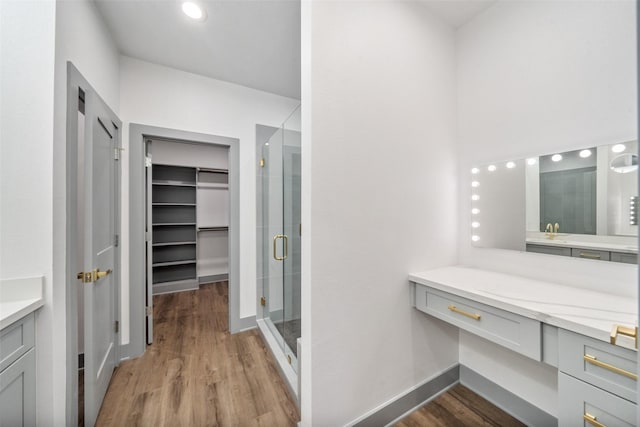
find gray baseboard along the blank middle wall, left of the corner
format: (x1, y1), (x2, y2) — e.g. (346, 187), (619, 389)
(348, 364), (460, 427)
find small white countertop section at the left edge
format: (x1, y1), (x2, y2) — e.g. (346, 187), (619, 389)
(0, 276), (44, 330)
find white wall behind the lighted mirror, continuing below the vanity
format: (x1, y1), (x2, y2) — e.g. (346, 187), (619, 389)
(457, 0), (637, 415)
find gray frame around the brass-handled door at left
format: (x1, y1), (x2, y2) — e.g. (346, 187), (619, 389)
(65, 62), (122, 425)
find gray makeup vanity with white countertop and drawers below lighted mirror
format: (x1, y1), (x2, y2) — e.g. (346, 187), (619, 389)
(409, 266), (637, 427)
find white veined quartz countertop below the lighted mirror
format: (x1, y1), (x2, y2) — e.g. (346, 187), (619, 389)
(409, 266), (638, 349)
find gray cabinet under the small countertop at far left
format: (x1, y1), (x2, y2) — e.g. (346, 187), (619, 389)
(0, 313), (36, 427)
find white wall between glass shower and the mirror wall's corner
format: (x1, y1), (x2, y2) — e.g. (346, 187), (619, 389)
(301, 1), (458, 426)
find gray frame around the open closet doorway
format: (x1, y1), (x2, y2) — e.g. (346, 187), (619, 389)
(126, 123), (242, 357)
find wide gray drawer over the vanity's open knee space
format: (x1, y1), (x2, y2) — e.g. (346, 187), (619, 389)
(416, 285), (542, 361)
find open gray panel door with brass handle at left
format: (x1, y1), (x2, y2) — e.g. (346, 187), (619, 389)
(83, 91), (119, 426)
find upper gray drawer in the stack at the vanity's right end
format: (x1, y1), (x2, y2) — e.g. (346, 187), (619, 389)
(558, 329), (638, 402)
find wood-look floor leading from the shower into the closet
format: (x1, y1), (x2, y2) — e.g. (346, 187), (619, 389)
(96, 282), (299, 427)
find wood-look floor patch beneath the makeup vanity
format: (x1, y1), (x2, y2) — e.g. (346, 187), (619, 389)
(394, 384), (525, 427)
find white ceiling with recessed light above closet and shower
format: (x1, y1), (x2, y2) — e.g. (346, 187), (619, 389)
(95, 0), (300, 99)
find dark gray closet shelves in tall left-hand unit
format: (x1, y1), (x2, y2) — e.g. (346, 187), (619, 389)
(151, 164), (197, 292)
